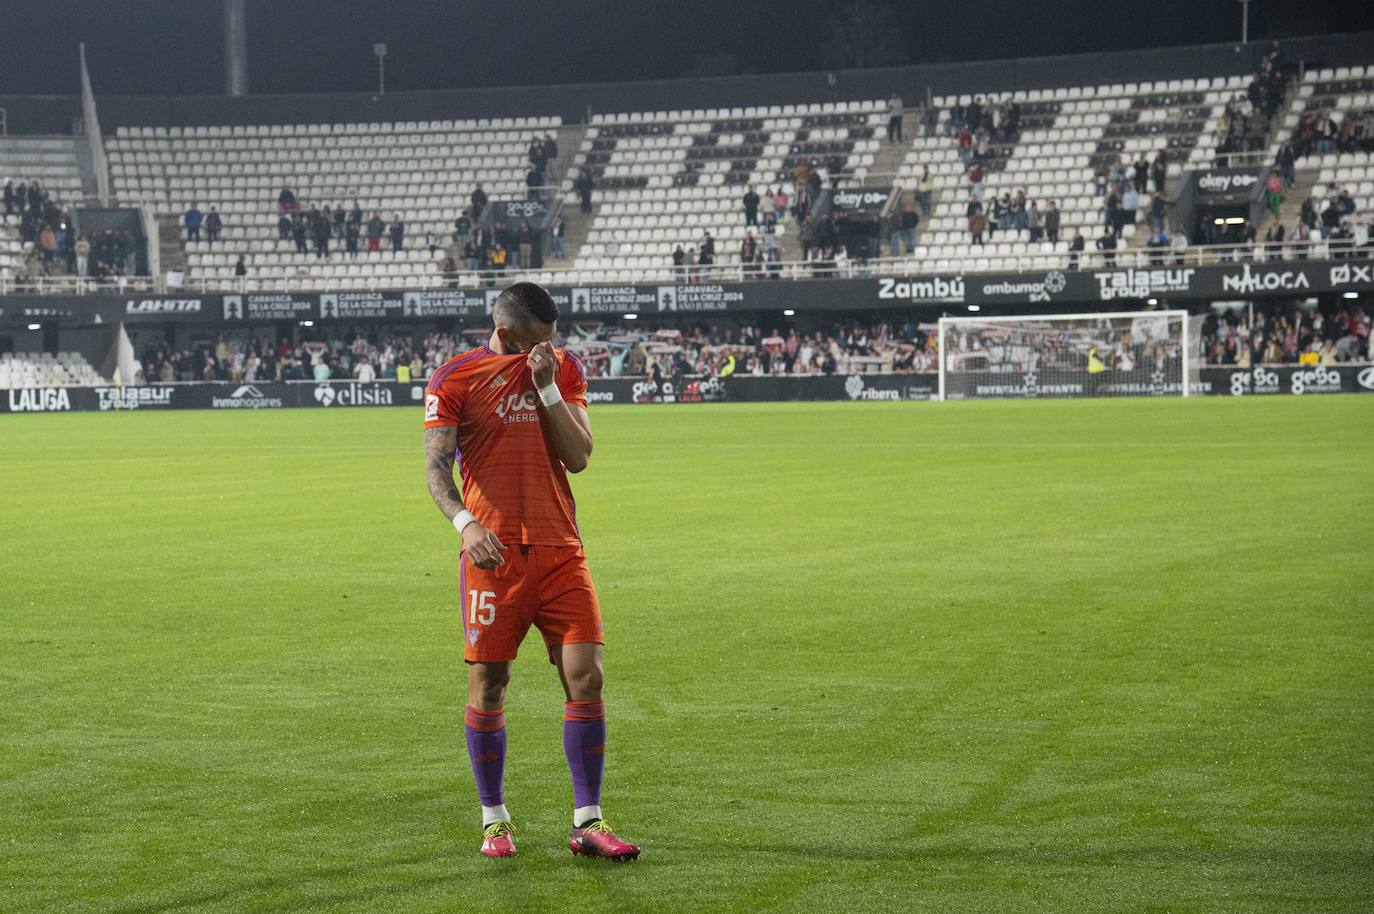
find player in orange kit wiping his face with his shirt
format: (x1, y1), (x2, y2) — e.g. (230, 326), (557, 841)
(425, 282), (639, 860)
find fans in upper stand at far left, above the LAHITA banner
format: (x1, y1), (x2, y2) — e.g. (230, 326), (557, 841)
(4, 179), (136, 281)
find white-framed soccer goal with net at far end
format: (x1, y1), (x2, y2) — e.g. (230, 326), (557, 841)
(940, 311), (1201, 400)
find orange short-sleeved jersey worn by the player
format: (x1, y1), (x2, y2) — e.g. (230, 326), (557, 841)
(425, 345), (587, 546)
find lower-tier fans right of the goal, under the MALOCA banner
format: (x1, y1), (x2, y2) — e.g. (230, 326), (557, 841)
(1202, 304), (1374, 368)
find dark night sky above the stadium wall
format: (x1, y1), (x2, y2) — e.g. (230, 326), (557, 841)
(0, 0), (1374, 95)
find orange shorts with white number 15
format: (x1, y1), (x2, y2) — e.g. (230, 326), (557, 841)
(458, 544), (606, 662)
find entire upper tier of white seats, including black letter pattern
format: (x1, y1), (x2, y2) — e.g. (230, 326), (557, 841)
(0, 53), (1374, 290)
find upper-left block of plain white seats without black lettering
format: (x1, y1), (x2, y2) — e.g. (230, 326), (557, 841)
(109, 117), (559, 290)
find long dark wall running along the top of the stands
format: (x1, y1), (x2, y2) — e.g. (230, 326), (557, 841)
(0, 32), (1374, 133)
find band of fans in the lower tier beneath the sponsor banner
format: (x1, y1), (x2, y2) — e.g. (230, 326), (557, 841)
(115, 304), (1374, 383)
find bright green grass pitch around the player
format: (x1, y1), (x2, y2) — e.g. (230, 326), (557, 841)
(0, 396), (1374, 914)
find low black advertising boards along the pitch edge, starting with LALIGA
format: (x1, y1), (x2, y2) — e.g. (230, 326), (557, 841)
(0, 366), (1374, 412)
